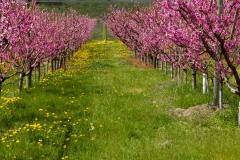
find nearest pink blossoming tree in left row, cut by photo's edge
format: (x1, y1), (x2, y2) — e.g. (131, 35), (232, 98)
(0, 0), (32, 94)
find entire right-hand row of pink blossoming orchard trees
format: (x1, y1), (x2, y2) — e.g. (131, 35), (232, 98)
(106, 0), (240, 107)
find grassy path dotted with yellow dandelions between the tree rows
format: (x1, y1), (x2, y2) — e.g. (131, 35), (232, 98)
(0, 42), (240, 160)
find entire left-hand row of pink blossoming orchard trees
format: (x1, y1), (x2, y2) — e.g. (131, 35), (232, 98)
(0, 0), (96, 93)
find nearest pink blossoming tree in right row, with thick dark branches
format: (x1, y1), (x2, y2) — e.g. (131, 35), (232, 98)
(157, 0), (240, 108)
